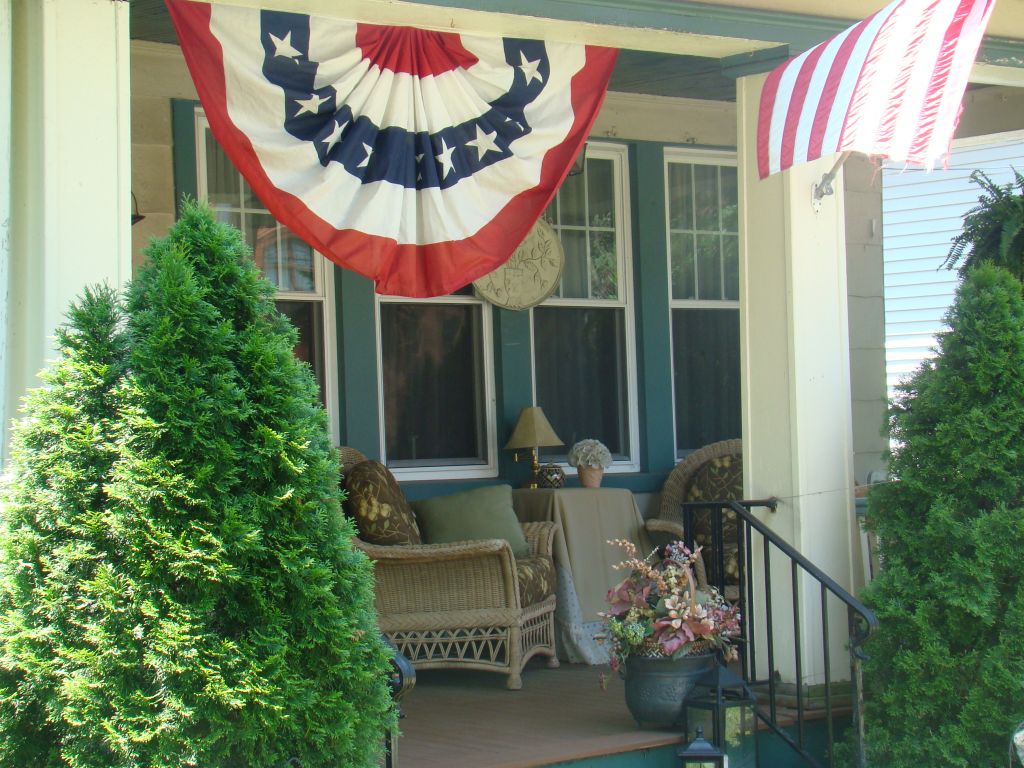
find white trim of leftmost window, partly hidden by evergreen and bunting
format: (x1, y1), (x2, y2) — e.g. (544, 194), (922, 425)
(193, 106), (341, 445)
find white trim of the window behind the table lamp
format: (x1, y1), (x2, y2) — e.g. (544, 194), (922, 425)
(529, 141), (640, 475)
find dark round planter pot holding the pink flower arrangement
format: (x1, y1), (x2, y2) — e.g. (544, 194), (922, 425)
(626, 651), (718, 728)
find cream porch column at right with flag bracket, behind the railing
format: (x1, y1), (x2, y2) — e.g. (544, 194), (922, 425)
(736, 76), (854, 683)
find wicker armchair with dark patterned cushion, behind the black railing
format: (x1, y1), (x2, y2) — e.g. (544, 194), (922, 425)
(646, 439), (743, 600)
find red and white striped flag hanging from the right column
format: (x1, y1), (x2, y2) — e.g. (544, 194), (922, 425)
(758, 0), (995, 178)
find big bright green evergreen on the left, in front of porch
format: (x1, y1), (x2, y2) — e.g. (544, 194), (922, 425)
(0, 204), (393, 768)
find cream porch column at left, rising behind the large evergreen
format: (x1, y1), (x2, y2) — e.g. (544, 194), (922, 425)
(0, 0), (131, 460)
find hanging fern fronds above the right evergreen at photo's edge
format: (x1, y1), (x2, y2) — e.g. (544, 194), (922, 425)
(944, 170), (1024, 282)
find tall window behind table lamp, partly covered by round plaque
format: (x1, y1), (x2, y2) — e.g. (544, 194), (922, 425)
(531, 143), (639, 470)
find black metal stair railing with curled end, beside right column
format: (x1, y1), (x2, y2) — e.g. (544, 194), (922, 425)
(682, 499), (879, 768)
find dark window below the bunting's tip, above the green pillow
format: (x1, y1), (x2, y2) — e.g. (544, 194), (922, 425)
(377, 289), (498, 480)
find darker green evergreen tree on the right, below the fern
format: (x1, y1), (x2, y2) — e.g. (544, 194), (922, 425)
(864, 266), (1024, 768)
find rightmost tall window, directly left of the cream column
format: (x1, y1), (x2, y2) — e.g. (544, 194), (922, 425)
(666, 150), (740, 455)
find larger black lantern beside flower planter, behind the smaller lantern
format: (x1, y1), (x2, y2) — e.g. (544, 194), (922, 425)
(686, 664), (757, 765)
